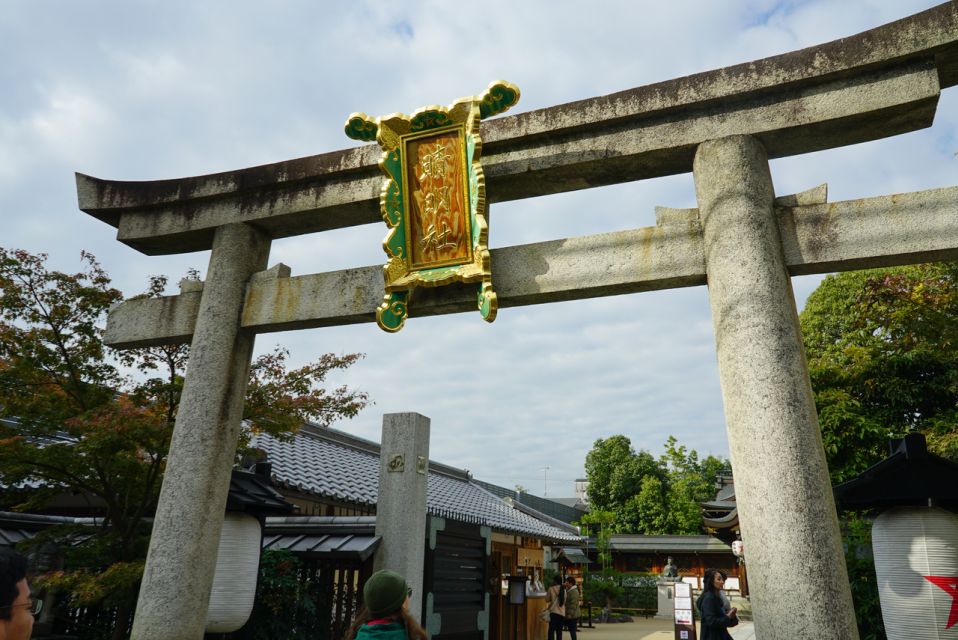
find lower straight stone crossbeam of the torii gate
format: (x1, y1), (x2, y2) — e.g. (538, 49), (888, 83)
(105, 187), (958, 348)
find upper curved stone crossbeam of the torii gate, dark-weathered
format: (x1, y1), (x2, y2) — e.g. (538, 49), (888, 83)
(77, 3), (958, 258)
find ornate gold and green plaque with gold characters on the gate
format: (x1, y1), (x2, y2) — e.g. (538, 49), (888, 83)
(346, 80), (519, 331)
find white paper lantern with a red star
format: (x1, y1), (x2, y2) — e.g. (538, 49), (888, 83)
(872, 507), (958, 640)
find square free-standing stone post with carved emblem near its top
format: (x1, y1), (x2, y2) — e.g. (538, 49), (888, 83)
(374, 413), (429, 622)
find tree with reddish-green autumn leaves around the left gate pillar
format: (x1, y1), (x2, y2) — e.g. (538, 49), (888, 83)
(0, 248), (368, 629)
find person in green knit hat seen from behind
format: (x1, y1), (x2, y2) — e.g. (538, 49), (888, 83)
(345, 570), (428, 640)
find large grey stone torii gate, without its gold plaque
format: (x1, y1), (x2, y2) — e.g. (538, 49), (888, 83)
(77, 3), (958, 640)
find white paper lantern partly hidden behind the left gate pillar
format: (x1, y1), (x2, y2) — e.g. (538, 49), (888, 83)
(206, 513), (263, 633)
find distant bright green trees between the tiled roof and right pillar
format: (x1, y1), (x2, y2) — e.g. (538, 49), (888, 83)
(585, 435), (729, 535)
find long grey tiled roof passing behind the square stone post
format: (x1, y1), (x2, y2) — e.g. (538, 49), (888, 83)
(254, 427), (581, 542)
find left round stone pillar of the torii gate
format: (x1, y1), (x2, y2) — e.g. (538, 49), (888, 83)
(132, 224), (270, 640)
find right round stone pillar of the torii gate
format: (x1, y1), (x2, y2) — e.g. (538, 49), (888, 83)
(693, 136), (858, 640)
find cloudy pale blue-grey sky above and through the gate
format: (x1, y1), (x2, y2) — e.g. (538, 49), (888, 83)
(0, 0), (958, 497)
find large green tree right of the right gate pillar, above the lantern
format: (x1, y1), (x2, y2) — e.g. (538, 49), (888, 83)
(801, 263), (958, 482)
